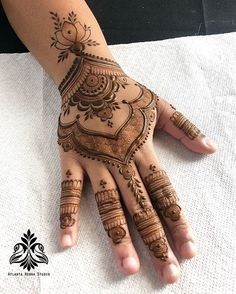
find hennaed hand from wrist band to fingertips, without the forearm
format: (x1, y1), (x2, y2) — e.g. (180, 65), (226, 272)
(58, 53), (218, 283)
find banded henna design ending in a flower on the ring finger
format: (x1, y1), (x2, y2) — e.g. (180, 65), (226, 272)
(95, 189), (126, 244)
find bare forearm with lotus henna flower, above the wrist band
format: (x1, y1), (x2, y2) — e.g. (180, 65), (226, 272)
(2, 0), (113, 85)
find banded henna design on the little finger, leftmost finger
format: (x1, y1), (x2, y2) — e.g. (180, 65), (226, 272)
(60, 180), (81, 229)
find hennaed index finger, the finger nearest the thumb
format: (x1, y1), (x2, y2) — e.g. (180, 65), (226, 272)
(135, 150), (196, 258)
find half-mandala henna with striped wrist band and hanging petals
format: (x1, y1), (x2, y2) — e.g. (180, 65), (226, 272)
(59, 54), (128, 127)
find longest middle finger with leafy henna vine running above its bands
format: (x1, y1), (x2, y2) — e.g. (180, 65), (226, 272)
(110, 164), (180, 283)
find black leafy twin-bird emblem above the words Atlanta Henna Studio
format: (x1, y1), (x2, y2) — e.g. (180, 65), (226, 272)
(9, 230), (48, 271)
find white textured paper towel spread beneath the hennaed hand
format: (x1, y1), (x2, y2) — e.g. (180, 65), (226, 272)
(0, 33), (236, 294)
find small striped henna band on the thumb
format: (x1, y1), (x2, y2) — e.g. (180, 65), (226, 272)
(170, 111), (201, 140)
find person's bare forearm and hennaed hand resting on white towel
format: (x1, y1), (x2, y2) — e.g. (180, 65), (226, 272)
(2, 0), (216, 283)
